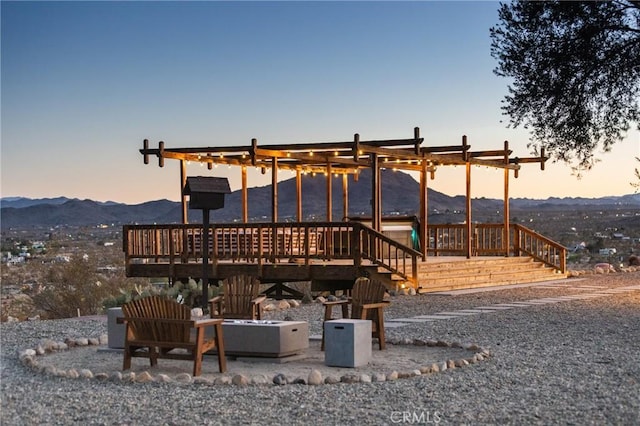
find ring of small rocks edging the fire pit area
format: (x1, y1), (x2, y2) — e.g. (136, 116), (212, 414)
(19, 334), (492, 386)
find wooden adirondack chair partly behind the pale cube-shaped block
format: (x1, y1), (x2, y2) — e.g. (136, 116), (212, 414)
(321, 277), (390, 350)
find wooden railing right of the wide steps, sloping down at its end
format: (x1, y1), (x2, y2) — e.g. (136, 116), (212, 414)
(427, 223), (567, 273)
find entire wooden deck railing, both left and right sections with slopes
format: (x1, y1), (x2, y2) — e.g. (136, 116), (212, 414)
(123, 222), (566, 283)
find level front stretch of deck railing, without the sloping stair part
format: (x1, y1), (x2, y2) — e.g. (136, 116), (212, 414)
(123, 222), (353, 264)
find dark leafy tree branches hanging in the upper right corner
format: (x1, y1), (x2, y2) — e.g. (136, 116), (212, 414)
(491, 0), (640, 169)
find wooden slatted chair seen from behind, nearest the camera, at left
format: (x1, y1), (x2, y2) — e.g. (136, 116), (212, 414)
(119, 296), (227, 376)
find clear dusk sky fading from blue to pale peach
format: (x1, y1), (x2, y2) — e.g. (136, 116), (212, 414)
(0, 1), (640, 204)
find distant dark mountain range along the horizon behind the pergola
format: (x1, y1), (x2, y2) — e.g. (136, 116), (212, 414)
(0, 170), (640, 229)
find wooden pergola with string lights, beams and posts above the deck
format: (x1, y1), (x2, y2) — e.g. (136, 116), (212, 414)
(140, 127), (547, 258)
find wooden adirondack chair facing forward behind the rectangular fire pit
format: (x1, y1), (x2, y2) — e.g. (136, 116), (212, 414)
(209, 275), (267, 320)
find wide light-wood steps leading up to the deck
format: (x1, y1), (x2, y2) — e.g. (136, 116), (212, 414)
(417, 256), (566, 293)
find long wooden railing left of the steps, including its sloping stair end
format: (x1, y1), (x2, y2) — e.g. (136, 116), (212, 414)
(123, 222), (421, 283)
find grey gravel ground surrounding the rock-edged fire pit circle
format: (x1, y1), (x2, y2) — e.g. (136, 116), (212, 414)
(0, 272), (640, 425)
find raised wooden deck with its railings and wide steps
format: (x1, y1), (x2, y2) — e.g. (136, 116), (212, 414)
(123, 222), (566, 292)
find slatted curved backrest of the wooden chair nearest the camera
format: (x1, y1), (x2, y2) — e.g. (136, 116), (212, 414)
(122, 296), (191, 342)
